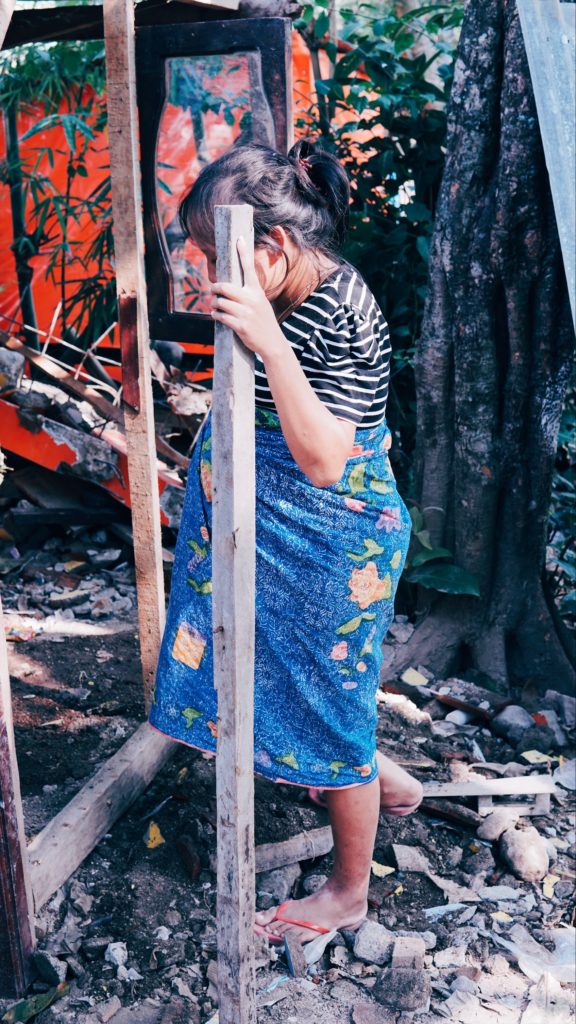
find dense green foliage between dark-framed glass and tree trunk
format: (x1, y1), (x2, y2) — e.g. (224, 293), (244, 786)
(296, 0), (463, 479)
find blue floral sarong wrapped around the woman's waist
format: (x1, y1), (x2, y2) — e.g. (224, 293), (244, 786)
(150, 410), (411, 788)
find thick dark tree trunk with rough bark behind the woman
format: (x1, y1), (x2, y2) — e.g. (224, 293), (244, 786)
(385, 0), (574, 692)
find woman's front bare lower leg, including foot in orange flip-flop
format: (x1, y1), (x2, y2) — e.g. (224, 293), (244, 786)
(256, 778), (380, 942)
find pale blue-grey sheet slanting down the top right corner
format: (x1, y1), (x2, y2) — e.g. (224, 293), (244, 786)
(517, 0), (576, 325)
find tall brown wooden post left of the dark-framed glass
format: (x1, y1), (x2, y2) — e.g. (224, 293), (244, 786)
(104, 0), (165, 706)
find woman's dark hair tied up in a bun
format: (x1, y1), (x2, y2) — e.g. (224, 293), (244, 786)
(178, 139), (349, 254)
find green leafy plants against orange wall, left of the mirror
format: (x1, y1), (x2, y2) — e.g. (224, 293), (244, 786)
(0, 41), (116, 347)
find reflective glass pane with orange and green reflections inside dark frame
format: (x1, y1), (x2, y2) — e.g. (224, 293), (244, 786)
(156, 51), (275, 313)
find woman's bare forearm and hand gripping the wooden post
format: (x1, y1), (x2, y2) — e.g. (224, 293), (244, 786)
(212, 242), (356, 487)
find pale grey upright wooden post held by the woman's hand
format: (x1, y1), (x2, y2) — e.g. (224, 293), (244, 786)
(212, 206), (256, 1024)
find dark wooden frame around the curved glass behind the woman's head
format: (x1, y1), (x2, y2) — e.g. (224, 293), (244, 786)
(136, 17), (292, 344)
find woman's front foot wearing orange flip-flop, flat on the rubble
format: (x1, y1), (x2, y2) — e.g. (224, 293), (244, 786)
(254, 882), (368, 942)
